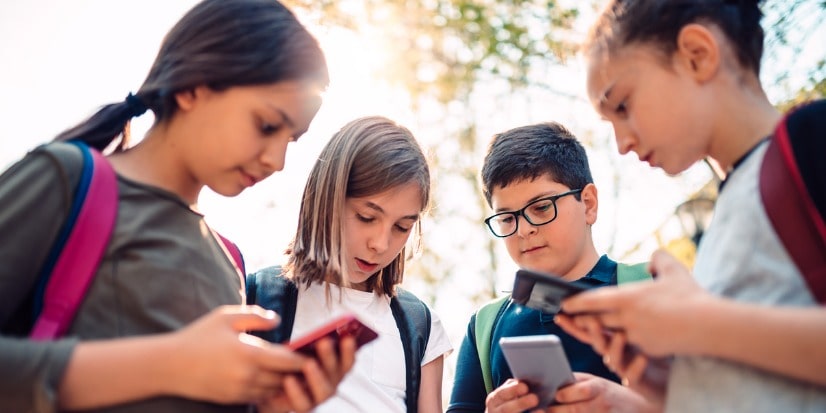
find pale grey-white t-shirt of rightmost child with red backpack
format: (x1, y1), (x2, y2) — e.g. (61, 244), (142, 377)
(666, 143), (826, 412)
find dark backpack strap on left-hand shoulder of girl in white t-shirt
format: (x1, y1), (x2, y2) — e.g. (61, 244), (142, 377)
(246, 266), (298, 343)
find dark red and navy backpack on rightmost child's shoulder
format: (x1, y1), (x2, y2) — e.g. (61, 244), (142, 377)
(759, 100), (826, 305)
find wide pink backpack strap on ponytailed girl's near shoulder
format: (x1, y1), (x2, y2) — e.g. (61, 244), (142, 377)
(30, 143), (118, 340)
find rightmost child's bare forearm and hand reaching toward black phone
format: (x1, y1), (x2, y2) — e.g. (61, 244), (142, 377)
(560, 251), (826, 386)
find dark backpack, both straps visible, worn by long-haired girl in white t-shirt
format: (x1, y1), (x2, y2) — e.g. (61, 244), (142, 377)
(247, 266), (430, 412)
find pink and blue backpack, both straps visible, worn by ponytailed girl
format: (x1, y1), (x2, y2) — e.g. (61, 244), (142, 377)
(29, 142), (244, 340)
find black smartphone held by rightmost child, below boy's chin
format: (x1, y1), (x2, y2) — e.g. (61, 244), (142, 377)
(511, 270), (591, 314)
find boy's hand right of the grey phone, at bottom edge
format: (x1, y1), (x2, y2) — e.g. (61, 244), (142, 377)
(547, 373), (659, 413)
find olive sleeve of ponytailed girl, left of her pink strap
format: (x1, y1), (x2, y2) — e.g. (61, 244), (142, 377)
(0, 145), (82, 412)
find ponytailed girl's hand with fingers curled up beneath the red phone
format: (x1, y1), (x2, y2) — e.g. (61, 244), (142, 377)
(258, 337), (356, 413)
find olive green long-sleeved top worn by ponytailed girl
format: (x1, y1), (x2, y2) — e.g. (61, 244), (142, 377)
(0, 143), (246, 412)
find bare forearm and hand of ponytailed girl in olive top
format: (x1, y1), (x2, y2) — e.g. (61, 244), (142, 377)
(58, 306), (309, 409)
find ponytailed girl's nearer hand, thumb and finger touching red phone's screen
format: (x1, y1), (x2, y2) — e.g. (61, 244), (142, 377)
(166, 306), (308, 404)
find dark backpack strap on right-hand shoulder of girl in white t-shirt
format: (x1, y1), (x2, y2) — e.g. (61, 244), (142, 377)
(390, 288), (430, 412)
